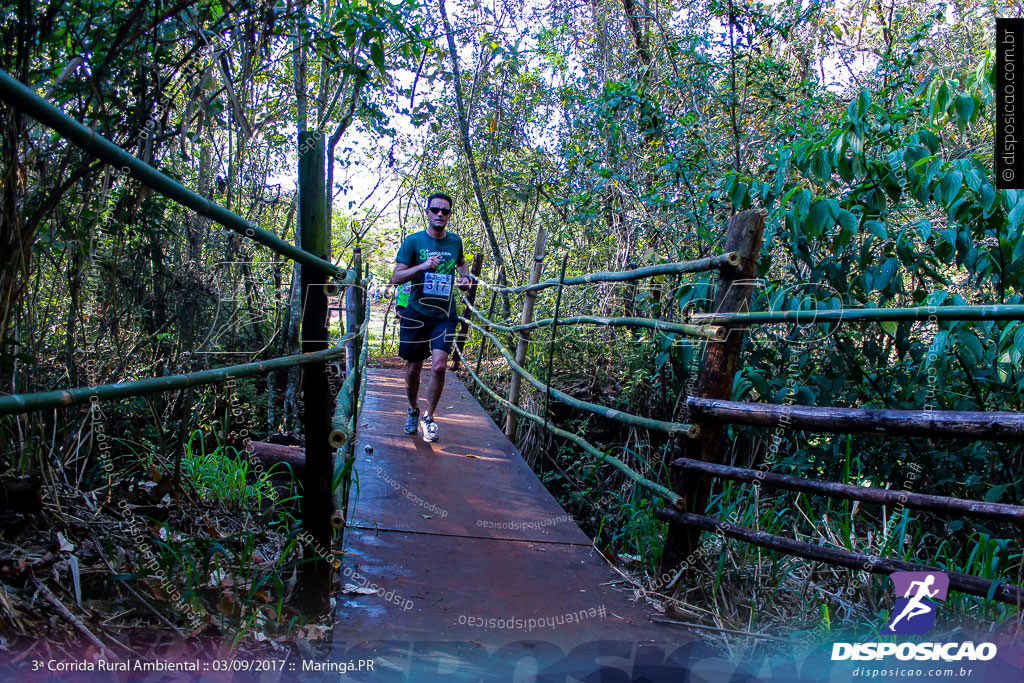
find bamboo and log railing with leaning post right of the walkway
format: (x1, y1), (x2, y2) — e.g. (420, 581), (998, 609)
(460, 210), (1024, 605)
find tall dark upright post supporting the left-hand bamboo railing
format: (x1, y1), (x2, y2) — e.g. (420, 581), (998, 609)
(298, 131), (334, 614)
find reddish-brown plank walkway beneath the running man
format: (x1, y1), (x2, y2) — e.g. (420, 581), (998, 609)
(334, 370), (746, 681)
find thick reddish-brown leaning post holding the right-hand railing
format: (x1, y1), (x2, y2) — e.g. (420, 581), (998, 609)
(659, 210), (765, 575)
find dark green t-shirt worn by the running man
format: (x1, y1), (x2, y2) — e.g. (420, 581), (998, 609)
(394, 230), (465, 317)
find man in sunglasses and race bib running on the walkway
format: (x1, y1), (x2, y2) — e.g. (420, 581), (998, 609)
(391, 193), (469, 441)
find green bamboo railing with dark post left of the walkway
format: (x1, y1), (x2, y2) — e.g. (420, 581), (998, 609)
(0, 70), (367, 613)
